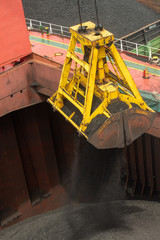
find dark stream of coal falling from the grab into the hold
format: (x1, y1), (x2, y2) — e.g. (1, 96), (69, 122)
(70, 135), (122, 202)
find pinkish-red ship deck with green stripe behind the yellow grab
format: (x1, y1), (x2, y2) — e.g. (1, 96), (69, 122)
(29, 31), (160, 94)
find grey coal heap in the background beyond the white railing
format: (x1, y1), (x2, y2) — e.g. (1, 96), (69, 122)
(22, 0), (159, 38)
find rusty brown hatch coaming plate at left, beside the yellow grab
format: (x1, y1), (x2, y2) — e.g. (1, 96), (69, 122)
(0, 54), (61, 117)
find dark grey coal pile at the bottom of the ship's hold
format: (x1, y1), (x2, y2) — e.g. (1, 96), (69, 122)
(0, 201), (160, 240)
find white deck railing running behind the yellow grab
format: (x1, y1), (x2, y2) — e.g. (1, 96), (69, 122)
(26, 18), (160, 59)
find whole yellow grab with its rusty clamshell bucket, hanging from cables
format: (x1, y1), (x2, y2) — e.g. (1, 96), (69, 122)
(48, 22), (155, 149)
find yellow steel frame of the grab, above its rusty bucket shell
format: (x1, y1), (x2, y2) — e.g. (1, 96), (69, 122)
(48, 22), (152, 134)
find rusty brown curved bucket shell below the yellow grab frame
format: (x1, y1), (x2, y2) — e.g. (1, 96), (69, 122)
(88, 108), (156, 149)
